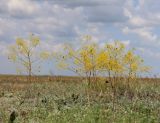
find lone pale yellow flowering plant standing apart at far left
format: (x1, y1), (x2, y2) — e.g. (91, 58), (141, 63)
(8, 34), (49, 81)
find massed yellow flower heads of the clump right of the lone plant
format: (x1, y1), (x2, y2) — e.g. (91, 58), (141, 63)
(59, 35), (150, 79)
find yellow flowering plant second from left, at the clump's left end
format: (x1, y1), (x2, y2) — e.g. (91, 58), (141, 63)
(57, 35), (98, 84)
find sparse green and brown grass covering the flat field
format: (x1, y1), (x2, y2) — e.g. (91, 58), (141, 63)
(0, 76), (160, 123)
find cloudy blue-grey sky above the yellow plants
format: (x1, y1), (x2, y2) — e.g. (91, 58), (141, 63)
(0, 0), (160, 74)
